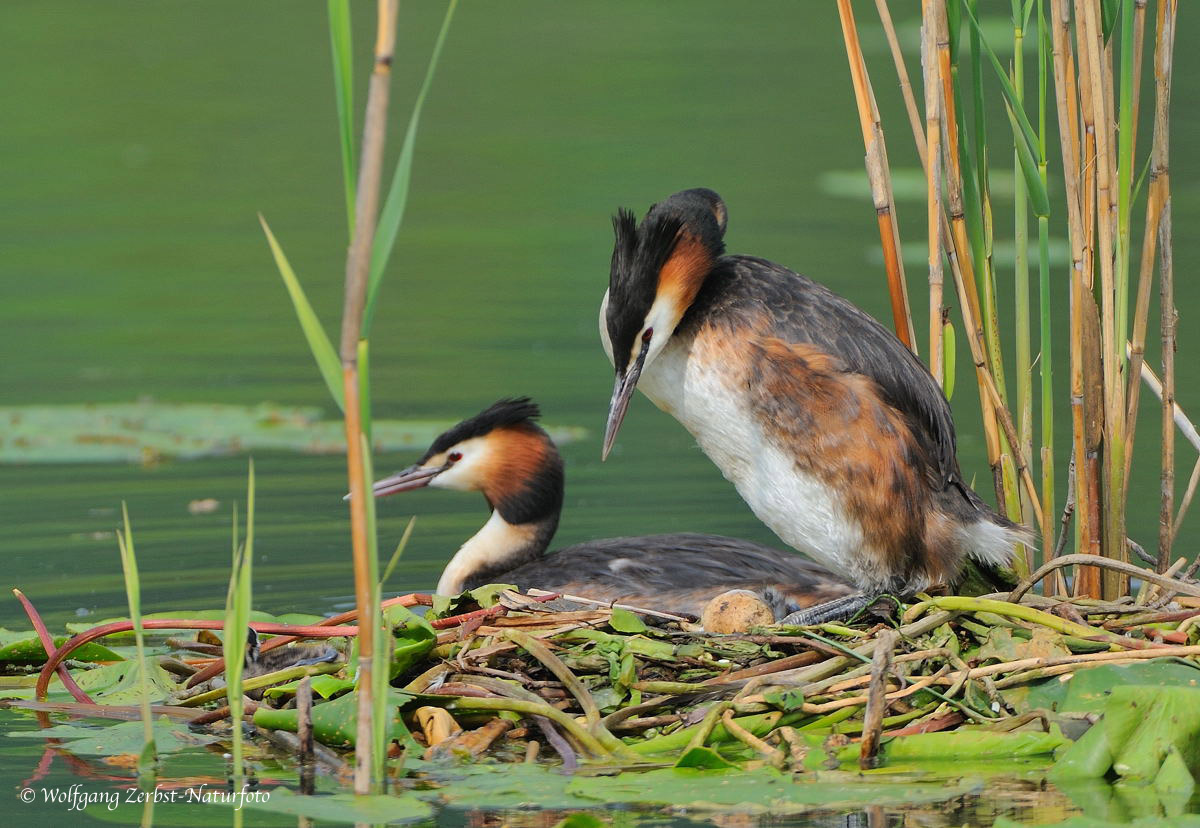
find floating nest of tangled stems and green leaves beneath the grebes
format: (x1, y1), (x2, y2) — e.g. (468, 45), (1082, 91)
(8, 556), (1200, 776)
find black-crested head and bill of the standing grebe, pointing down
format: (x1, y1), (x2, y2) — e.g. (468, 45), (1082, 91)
(601, 188), (726, 457)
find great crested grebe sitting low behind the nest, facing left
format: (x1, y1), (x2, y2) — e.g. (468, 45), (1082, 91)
(373, 398), (852, 618)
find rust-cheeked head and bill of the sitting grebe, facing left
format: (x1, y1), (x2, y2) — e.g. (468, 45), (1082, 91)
(372, 397), (563, 524)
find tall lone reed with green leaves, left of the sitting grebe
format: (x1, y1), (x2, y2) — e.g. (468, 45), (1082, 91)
(259, 0), (457, 793)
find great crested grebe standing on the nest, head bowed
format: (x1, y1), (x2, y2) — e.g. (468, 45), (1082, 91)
(600, 188), (1030, 623)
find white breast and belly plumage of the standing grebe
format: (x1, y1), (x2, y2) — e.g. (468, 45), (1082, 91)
(638, 340), (863, 575)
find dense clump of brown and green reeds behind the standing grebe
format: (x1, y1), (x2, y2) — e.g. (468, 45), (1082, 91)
(864, 0), (1180, 598)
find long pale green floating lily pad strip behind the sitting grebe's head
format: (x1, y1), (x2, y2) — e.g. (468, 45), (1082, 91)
(0, 400), (586, 463)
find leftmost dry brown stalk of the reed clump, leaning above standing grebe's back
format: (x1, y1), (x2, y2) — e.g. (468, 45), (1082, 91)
(838, 0), (917, 353)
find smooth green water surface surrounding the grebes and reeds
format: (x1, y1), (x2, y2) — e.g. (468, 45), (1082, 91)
(0, 1), (1200, 818)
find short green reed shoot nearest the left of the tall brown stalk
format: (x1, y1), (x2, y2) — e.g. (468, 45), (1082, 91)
(223, 458), (254, 791)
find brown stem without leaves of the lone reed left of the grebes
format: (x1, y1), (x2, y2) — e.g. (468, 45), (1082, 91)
(340, 0), (398, 793)
